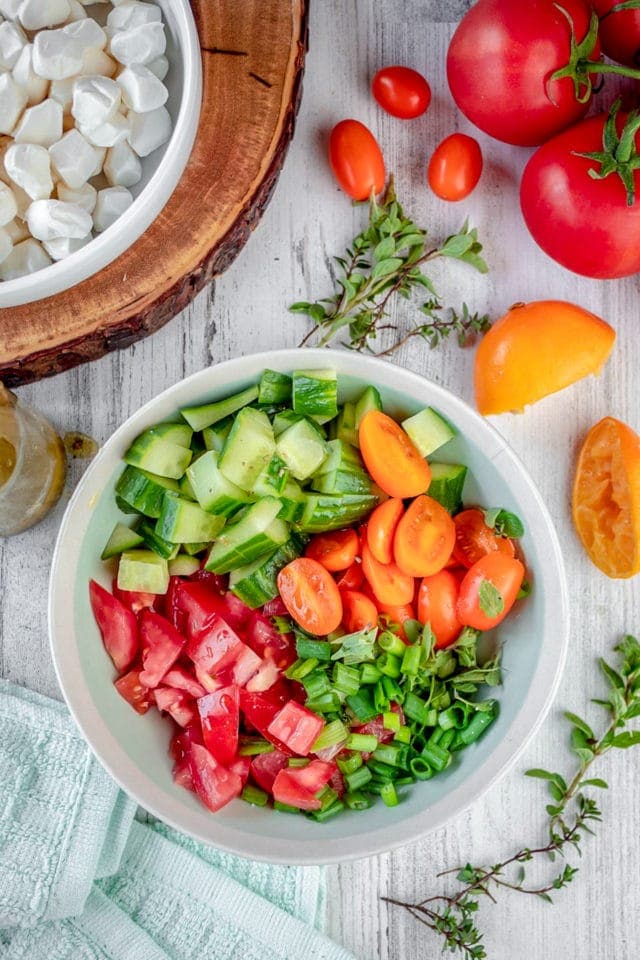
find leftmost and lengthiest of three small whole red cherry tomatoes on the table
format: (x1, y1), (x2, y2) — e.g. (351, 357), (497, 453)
(329, 120), (385, 200)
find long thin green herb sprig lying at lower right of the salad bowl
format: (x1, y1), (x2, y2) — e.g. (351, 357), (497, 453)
(383, 636), (640, 960)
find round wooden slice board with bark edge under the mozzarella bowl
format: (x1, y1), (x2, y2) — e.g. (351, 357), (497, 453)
(0, 0), (308, 386)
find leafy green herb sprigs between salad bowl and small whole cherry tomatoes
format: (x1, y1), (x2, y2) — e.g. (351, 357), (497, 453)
(290, 179), (490, 354)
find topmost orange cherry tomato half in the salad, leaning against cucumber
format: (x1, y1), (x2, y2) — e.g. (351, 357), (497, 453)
(358, 410), (431, 499)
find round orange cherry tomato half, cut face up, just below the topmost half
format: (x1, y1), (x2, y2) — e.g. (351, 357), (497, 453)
(393, 494), (456, 577)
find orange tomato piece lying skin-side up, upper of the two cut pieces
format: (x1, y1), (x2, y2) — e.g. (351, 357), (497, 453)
(474, 300), (616, 414)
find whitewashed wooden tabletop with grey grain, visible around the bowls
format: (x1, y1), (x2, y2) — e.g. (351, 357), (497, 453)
(0, 0), (640, 960)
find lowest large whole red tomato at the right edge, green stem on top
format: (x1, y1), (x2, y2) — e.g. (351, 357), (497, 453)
(520, 114), (640, 280)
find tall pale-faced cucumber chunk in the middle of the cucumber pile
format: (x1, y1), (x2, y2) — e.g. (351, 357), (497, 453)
(218, 407), (276, 490)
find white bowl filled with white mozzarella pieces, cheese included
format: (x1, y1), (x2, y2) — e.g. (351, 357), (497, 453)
(0, 0), (202, 308)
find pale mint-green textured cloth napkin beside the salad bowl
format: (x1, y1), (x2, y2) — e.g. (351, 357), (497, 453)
(0, 681), (352, 960)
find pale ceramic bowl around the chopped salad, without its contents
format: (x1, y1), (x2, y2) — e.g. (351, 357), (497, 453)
(49, 350), (568, 863)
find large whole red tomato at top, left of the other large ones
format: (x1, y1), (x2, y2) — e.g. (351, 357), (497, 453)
(447, 0), (600, 146)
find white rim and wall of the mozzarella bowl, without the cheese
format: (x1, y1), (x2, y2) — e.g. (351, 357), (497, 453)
(0, 0), (202, 308)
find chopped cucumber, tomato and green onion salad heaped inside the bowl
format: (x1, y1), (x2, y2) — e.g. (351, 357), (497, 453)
(90, 370), (527, 821)
